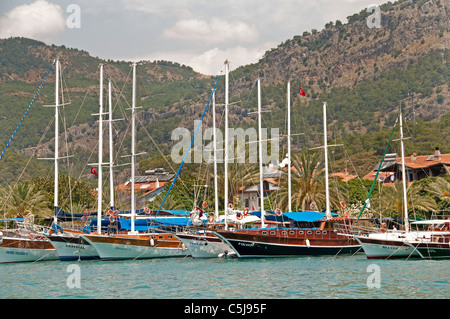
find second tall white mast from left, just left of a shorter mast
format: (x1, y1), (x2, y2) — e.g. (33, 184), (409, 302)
(97, 64), (103, 234)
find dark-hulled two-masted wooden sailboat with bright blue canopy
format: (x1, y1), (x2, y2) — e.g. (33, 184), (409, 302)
(215, 79), (360, 258)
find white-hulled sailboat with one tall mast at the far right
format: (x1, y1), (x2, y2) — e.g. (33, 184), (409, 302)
(354, 110), (450, 259)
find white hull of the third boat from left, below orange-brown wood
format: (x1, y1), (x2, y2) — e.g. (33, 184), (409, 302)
(82, 235), (189, 260)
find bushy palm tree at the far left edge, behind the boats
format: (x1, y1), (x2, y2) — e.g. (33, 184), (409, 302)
(2, 182), (53, 218)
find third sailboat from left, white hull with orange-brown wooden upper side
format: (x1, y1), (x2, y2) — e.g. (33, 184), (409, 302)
(81, 63), (188, 260)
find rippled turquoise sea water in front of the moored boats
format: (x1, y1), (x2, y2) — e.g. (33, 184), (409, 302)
(0, 254), (450, 299)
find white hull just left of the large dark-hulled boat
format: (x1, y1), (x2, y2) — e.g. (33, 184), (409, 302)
(176, 234), (235, 258)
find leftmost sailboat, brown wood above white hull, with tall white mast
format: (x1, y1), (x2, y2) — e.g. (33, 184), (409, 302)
(0, 59), (64, 263)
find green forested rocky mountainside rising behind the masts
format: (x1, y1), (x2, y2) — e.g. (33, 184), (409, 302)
(0, 0), (450, 188)
